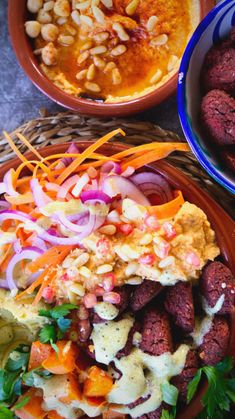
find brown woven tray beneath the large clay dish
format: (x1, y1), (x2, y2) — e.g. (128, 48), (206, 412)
(0, 110), (235, 217)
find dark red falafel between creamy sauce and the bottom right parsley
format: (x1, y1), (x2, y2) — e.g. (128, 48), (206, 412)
(171, 349), (198, 403)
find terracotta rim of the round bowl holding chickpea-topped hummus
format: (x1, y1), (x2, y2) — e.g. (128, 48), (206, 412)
(8, 0), (215, 117)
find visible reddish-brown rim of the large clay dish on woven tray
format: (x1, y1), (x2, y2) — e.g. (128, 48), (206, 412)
(0, 141), (235, 419)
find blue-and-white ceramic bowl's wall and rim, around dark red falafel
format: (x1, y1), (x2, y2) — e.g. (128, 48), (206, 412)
(178, 0), (235, 194)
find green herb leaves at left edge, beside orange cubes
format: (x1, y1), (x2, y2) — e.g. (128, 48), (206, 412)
(0, 345), (29, 408)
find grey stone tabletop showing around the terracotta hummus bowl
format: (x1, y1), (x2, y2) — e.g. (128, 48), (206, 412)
(0, 0), (182, 135)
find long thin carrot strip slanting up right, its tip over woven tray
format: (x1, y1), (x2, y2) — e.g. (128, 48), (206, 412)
(57, 128), (126, 185)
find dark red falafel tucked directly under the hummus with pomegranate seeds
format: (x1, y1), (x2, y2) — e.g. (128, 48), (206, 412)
(130, 280), (163, 311)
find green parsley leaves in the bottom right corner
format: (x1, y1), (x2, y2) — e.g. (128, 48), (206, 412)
(187, 357), (235, 419)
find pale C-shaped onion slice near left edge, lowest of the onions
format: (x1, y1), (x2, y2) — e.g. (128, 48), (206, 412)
(6, 247), (43, 290)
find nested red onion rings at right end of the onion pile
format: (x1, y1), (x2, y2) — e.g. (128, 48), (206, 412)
(130, 172), (173, 204)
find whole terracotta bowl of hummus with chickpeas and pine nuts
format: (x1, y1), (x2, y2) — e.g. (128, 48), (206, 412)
(9, 0), (214, 116)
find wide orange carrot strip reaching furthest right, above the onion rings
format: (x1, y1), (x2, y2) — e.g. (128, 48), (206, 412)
(121, 143), (190, 170)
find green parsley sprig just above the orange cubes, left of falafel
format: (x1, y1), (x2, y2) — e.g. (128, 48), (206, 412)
(39, 304), (75, 353)
